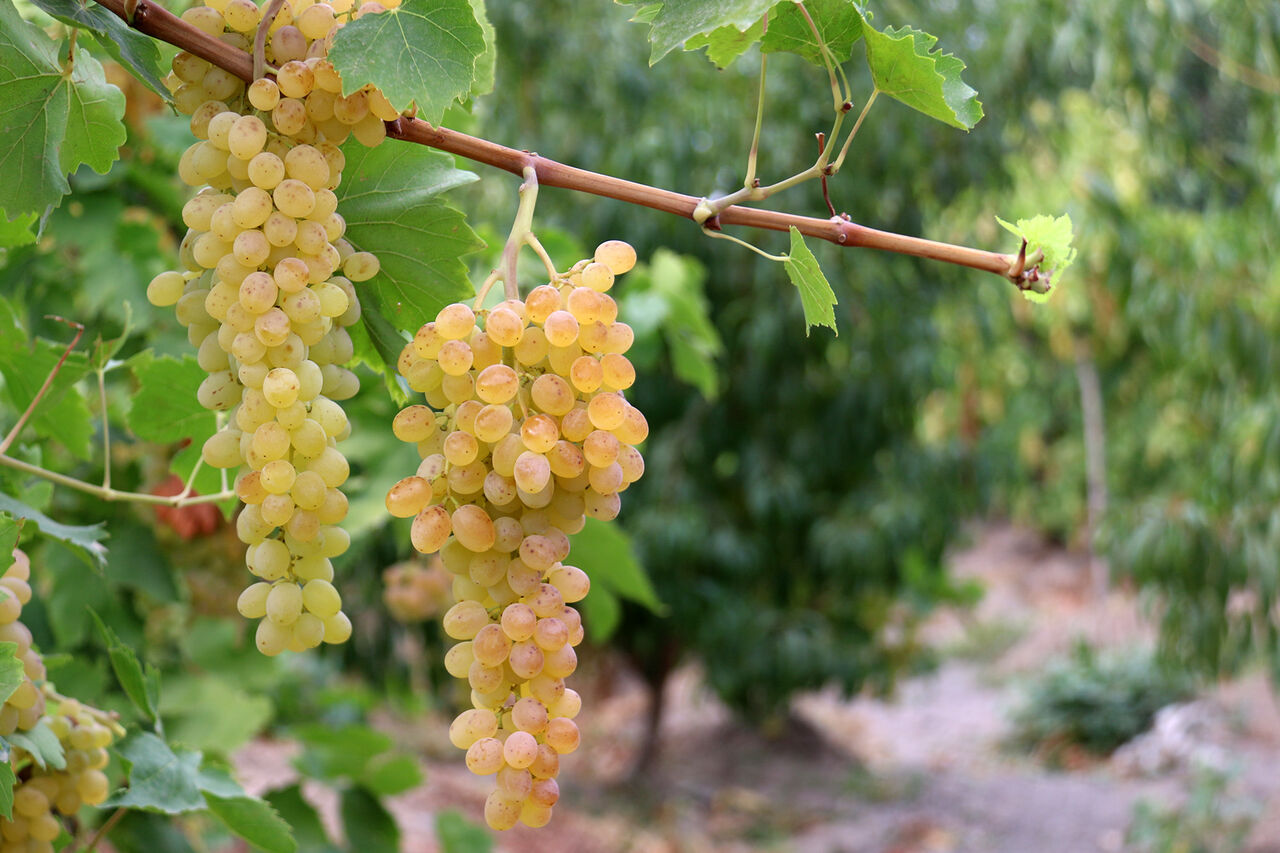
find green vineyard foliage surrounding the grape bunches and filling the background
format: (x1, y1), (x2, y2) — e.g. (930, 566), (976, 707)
(0, 0), (1264, 850)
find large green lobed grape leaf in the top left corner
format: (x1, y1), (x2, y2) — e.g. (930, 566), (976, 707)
(0, 0), (125, 215)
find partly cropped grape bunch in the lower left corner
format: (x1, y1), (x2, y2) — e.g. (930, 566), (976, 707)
(0, 549), (115, 853)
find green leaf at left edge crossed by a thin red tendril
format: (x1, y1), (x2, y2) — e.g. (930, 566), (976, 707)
(0, 298), (93, 459)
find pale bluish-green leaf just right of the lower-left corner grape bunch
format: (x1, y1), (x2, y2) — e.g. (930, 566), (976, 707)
(104, 733), (205, 815)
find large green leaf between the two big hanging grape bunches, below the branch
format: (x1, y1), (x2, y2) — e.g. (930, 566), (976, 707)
(338, 139), (484, 338)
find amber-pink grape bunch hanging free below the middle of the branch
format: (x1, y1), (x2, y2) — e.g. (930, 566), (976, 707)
(387, 241), (649, 829)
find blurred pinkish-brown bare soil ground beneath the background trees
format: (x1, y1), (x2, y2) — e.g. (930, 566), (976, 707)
(242, 526), (1280, 853)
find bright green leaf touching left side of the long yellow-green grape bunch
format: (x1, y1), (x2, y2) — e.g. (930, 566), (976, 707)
(127, 350), (218, 444)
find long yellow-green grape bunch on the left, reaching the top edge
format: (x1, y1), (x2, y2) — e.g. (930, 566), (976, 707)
(147, 0), (398, 654)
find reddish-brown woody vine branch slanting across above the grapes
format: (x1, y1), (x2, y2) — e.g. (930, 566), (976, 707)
(87, 0), (1023, 284)
